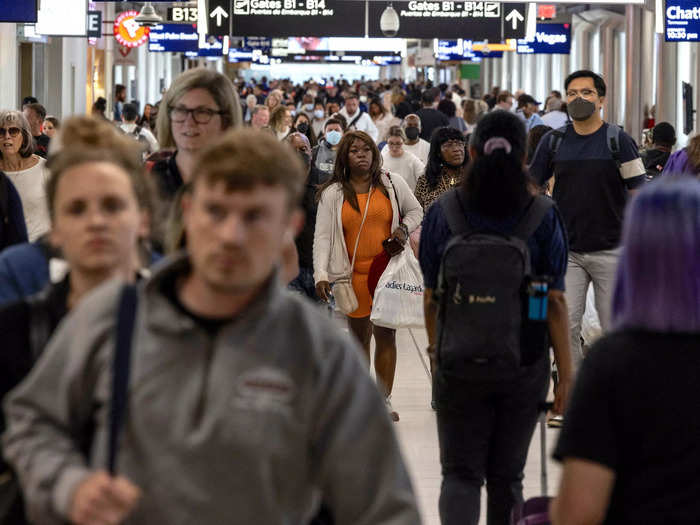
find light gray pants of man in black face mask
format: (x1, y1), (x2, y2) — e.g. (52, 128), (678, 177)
(564, 248), (620, 370)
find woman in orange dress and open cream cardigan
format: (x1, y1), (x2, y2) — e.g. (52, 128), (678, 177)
(313, 131), (423, 421)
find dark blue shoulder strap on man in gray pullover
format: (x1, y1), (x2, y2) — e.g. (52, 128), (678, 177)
(107, 284), (138, 475)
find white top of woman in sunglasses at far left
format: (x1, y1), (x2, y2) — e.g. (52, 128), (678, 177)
(5, 157), (51, 242)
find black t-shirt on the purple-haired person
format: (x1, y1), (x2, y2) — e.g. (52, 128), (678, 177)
(554, 331), (700, 525)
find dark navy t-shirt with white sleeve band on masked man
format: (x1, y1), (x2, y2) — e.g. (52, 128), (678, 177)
(530, 123), (645, 253)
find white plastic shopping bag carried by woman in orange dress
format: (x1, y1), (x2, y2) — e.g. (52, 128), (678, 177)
(370, 248), (425, 328)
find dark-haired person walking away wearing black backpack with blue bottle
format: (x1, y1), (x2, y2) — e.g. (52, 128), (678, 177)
(420, 111), (571, 525)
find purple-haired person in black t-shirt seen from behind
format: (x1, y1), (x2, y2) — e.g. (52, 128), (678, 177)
(551, 176), (700, 525)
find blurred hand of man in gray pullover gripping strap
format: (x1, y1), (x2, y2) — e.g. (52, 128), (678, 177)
(69, 470), (141, 525)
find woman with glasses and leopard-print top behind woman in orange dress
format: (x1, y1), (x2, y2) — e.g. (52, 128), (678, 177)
(416, 127), (469, 213)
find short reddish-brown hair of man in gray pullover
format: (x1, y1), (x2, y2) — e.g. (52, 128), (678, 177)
(192, 128), (306, 209)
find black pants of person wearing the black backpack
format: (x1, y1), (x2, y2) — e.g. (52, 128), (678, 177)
(434, 358), (549, 525)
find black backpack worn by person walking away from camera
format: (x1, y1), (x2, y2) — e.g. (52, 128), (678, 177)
(435, 189), (554, 381)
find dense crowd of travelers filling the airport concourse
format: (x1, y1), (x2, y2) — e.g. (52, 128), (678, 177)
(0, 68), (700, 525)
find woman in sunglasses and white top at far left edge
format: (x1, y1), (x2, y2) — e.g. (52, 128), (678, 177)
(0, 111), (51, 241)
